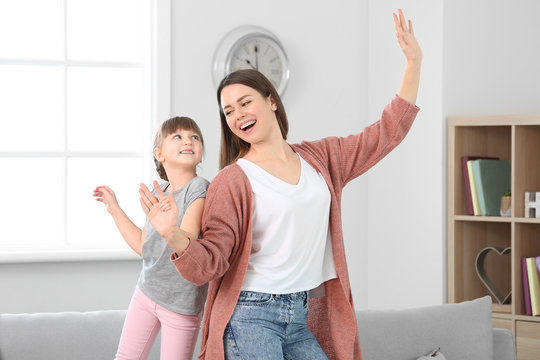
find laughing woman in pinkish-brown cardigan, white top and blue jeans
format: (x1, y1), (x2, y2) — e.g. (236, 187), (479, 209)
(141, 10), (422, 360)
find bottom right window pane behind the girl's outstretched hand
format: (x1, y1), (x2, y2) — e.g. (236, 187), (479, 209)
(67, 158), (146, 249)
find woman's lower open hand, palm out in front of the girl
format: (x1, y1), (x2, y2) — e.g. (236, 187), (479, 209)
(139, 181), (178, 237)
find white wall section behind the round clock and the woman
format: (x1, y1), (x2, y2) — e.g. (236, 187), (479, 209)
(172, 0), (372, 305)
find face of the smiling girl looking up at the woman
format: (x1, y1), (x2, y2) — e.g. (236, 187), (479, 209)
(154, 129), (203, 171)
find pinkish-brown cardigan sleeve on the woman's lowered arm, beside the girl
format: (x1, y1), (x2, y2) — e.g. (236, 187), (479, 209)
(171, 168), (251, 286)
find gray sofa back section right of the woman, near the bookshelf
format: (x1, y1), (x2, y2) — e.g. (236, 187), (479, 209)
(357, 296), (493, 360)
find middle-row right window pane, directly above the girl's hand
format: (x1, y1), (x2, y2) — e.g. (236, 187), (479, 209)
(68, 67), (143, 152)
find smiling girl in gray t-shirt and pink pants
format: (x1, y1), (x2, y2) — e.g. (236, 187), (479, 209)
(94, 117), (208, 360)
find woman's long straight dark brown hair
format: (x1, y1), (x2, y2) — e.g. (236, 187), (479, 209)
(217, 69), (289, 169)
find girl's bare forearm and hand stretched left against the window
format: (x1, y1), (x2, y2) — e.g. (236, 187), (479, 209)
(94, 186), (146, 255)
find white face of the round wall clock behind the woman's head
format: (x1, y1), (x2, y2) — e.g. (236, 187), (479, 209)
(226, 35), (289, 94)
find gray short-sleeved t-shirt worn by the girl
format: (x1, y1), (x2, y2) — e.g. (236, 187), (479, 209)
(137, 177), (208, 315)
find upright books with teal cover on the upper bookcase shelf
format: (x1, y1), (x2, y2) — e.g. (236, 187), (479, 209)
(461, 156), (511, 216)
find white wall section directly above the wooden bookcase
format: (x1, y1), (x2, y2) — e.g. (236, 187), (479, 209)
(443, 0), (540, 116)
